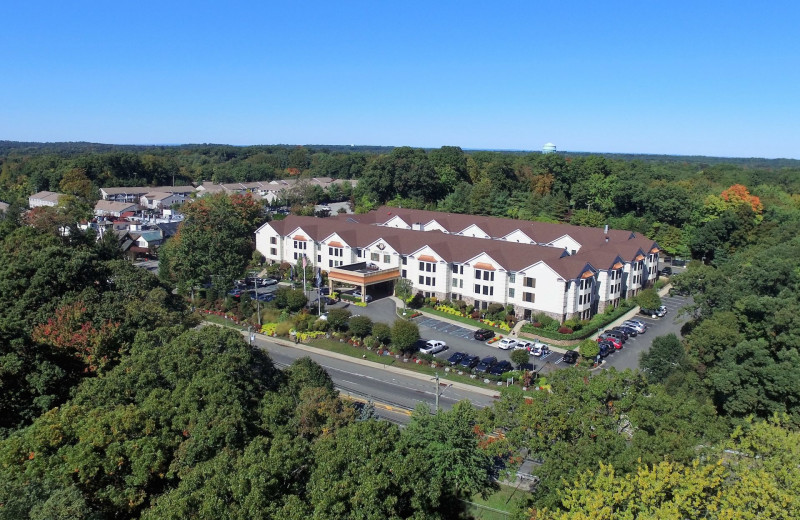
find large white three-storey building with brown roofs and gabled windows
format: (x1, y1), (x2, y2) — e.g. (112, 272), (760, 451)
(256, 207), (659, 321)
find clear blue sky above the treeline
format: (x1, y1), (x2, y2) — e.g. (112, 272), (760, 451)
(0, 0), (800, 158)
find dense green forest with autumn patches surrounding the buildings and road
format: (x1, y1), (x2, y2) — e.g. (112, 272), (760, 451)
(0, 143), (800, 519)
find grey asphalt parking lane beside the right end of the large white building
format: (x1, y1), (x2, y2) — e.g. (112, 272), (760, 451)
(603, 296), (689, 370)
